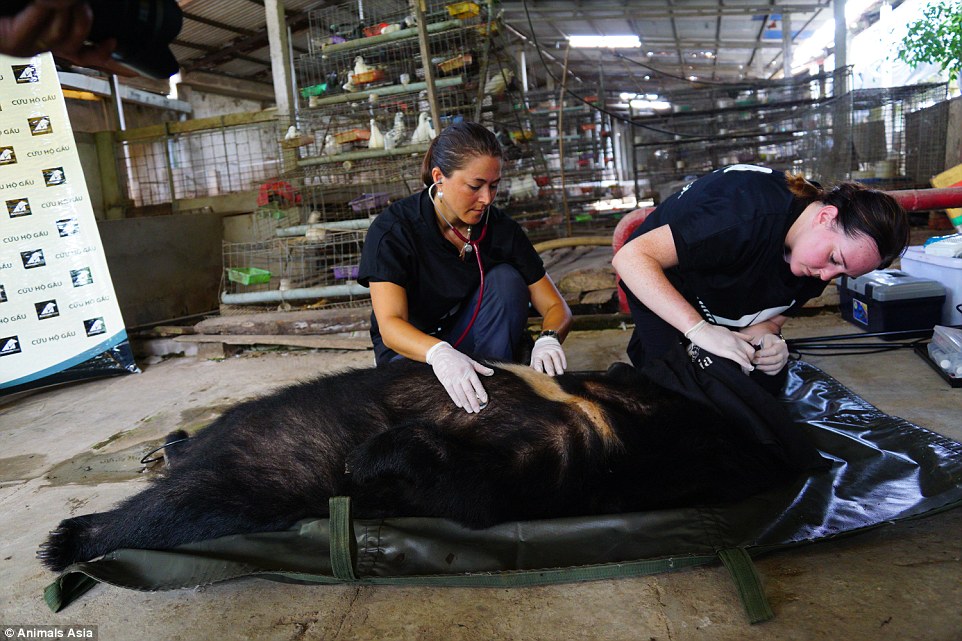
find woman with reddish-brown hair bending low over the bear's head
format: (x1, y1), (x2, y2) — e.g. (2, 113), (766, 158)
(613, 165), (909, 376)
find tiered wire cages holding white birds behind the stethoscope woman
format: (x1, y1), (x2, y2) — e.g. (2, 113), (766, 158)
(218, 0), (496, 305)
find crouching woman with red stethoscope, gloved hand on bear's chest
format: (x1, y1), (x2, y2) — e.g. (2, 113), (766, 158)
(358, 122), (571, 413)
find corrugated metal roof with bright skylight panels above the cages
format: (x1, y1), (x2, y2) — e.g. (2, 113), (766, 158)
(161, 0), (860, 90)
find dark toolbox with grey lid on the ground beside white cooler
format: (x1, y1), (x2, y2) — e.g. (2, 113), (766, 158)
(838, 269), (945, 332)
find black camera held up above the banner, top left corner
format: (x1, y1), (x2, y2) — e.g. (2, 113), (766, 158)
(0, 0), (183, 79)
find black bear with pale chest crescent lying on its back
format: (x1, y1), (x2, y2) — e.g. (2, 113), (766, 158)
(38, 362), (797, 571)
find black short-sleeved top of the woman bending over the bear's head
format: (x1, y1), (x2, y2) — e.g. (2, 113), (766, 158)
(629, 165), (826, 327)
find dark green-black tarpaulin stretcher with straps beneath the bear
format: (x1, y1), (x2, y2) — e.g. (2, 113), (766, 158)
(45, 361), (962, 621)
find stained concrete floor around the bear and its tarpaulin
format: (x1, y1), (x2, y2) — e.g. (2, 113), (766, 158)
(0, 314), (962, 641)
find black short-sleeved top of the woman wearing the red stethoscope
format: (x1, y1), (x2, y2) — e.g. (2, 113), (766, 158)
(357, 189), (545, 363)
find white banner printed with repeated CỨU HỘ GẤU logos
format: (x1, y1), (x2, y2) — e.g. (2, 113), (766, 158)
(0, 53), (139, 395)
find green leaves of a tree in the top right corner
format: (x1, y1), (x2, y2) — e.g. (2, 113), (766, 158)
(897, 0), (962, 82)
